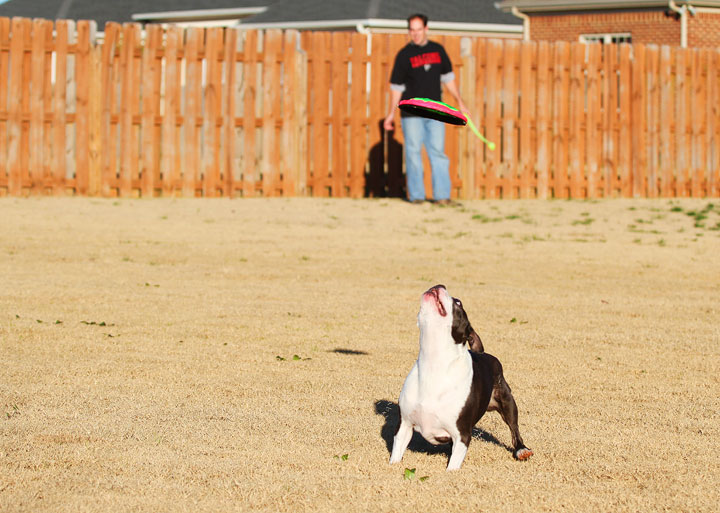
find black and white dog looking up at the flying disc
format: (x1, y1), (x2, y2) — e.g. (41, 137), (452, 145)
(390, 285), (532, 470)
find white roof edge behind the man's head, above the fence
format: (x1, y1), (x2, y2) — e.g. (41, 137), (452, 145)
(237, 18), (523, 34)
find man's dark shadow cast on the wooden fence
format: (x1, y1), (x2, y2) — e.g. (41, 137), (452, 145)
(365, 119), (406, 198)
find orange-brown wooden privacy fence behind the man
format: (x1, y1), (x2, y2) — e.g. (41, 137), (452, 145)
(0, 18), (720, 198)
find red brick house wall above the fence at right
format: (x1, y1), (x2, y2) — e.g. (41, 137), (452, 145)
(530, 10), (696, 46)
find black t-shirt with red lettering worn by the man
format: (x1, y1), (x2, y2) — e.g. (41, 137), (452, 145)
(390, 41), (452, 116)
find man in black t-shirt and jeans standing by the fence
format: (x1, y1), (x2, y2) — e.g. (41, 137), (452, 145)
(383, 14), (467, 204)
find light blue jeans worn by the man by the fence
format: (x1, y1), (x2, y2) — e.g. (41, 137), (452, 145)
(402, 116), (450, 201)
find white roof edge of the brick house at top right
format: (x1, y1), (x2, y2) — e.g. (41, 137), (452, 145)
(495, 0), (720, 12)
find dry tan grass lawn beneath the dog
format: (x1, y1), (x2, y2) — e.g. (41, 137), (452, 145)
(0, 198), (720, 512)
